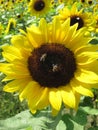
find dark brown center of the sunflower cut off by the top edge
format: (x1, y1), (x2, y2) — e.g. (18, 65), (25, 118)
(34, 0), (45, 11)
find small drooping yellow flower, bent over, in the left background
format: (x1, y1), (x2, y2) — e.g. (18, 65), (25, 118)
(5, 18), (16, 34)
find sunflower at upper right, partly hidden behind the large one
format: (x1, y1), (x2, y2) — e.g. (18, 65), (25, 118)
(59, 3), (94, 29)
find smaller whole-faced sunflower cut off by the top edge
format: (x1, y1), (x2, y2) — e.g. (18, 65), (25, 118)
(28, 0), (51, 17)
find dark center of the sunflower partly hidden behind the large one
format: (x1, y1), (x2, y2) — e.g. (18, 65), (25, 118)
(70, 16), (84, 29)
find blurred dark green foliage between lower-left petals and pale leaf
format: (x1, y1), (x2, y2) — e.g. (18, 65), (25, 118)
(0, 75), (27, 119)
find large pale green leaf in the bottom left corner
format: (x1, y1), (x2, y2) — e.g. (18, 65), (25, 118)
(0, 110), (48, 130)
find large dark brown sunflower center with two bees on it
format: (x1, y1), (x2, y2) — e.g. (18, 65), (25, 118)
(28, 44), (76, 88)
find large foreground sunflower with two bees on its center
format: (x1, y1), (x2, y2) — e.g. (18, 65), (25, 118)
(0, 18), (98, 115)
